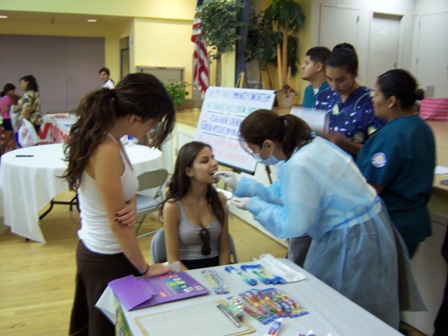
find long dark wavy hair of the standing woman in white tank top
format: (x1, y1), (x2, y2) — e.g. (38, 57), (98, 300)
(62, 73), (175, 190)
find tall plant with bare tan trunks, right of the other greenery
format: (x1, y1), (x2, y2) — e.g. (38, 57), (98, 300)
(263, 0), (305, 107)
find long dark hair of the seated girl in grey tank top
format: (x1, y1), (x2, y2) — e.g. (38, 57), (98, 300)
(160, 141), (225, 225)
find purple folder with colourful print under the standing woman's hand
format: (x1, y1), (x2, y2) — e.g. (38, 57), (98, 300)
(109, 272), (209, 310)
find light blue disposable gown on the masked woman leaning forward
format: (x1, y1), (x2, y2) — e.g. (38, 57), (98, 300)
(234, 137), (424, 328)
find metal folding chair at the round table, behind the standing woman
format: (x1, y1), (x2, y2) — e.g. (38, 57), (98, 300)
(136, 169), (168, 238)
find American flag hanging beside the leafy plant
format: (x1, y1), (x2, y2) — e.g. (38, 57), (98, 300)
(191, 0), (208, 93)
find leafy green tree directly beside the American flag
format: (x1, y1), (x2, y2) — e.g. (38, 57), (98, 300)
(201, 0), (244, 86)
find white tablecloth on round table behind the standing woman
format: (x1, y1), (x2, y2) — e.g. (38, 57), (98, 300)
(0, 144), (164, 242)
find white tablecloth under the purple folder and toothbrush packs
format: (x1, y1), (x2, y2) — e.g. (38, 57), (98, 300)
(96, 259), (401, 336)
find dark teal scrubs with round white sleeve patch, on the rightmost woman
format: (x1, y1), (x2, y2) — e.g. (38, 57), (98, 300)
(356, 115), (435, 244)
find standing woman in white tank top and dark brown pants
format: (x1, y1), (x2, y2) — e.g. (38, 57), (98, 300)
(63, 74), (175, 336)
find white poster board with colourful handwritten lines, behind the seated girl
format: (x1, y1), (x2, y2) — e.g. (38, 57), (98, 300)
(195, 86), (275, 174)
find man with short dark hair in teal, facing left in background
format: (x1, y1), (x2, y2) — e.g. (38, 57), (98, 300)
(301, 47), (330, 108)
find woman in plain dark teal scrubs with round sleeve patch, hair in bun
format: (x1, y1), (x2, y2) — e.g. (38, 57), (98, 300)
(356, 69), (435, 257)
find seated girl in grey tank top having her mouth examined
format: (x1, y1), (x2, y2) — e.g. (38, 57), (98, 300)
(160, 141), (230, 270)
